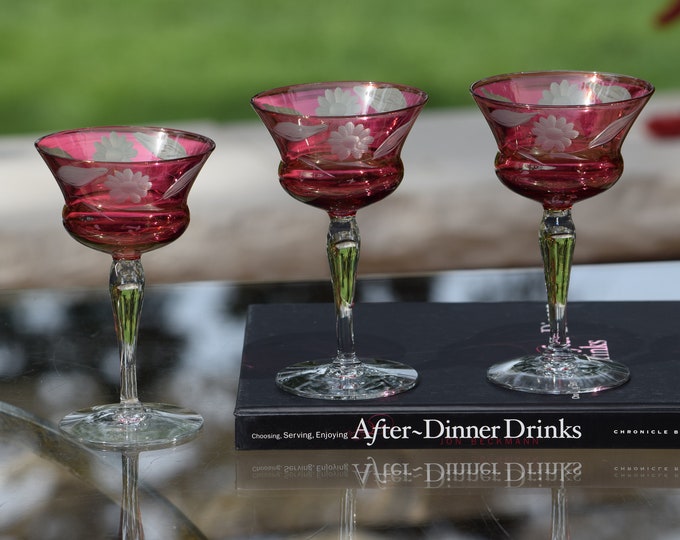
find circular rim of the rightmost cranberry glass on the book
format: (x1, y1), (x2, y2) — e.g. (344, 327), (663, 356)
(470, 69), (655, 109)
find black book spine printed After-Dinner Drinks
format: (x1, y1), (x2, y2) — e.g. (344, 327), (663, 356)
(235, 410), (680, 450)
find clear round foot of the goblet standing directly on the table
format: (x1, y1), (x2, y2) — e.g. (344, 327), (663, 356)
(59, 403), (203, 450)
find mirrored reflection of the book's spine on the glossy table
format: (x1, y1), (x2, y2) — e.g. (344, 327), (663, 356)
(237, 449), (680, 490)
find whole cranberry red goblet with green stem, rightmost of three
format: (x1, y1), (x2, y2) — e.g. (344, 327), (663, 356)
(471, 71), (654, 394)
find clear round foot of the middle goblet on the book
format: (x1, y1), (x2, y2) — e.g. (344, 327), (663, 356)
(276, 358), (418, 400)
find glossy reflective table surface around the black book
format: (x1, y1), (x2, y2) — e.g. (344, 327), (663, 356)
(0, 262), (680, 540)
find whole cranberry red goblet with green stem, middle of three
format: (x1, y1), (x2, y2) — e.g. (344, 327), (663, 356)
(251, 81), (427, 400)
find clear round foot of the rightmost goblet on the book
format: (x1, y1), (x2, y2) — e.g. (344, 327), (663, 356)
(487, 355), (630, 394)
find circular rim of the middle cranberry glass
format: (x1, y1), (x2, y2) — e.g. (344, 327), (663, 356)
(250, 80), (430, 118)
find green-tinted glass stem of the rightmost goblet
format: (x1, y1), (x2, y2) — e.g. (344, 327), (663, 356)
(539, 209), (576, 354)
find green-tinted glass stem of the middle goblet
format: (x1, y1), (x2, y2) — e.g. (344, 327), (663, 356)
(326, 216), (361, 367)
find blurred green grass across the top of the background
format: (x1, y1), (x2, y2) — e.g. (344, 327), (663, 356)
(0, 0), (680, 134)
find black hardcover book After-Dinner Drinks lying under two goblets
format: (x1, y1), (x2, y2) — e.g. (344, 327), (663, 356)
(234, 302), (680, 450)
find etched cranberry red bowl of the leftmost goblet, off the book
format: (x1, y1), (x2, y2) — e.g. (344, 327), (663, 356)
(41, 127), (210, 258)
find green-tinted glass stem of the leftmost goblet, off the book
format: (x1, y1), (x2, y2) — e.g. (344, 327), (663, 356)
(109, 259), (144, 413)
